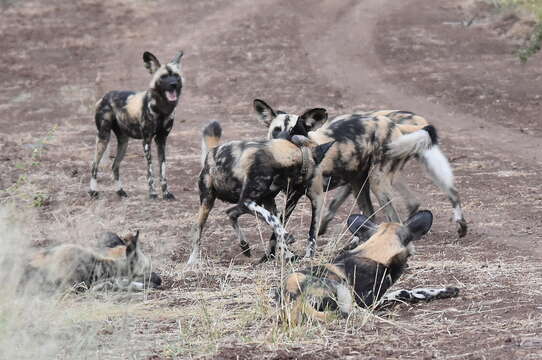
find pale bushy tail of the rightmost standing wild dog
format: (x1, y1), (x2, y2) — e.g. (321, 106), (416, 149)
(386, 125), (455, 202)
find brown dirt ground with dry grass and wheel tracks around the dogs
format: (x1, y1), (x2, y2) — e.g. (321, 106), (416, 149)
(0, 0), (542, 359)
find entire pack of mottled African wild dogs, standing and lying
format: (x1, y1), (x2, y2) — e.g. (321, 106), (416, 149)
(24, 52), (467, 321)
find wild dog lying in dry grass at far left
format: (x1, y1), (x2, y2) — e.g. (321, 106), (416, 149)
(22, 231), (160, 291)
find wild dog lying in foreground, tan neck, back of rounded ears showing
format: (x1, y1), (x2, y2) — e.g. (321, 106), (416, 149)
(275, 211), (459, 323)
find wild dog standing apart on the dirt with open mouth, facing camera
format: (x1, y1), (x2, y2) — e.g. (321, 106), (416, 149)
(89, 51), (184, 199)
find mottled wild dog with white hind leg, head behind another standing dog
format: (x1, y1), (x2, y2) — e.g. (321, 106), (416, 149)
(254, 99), (467, 237)
